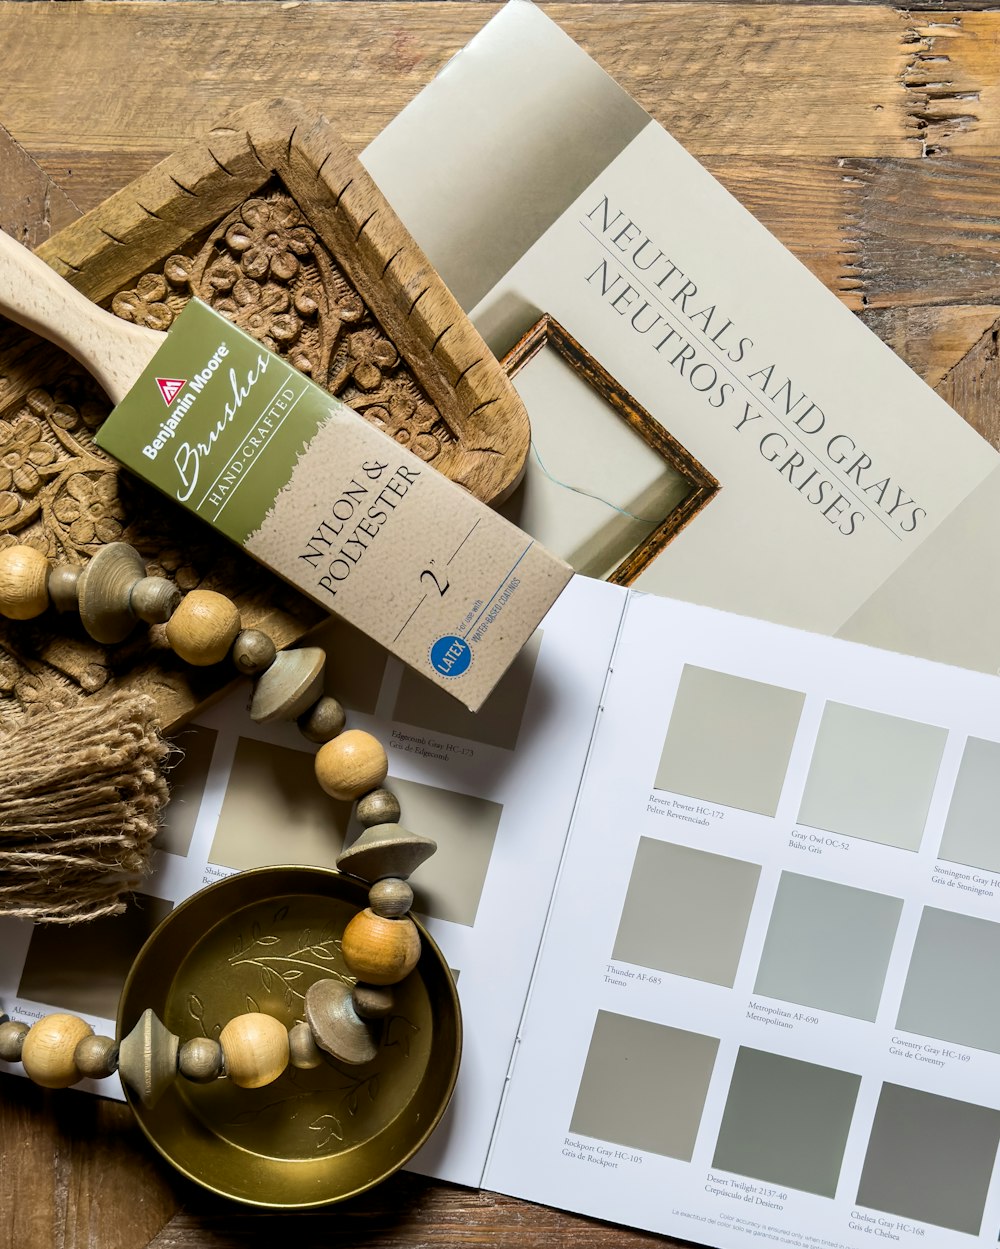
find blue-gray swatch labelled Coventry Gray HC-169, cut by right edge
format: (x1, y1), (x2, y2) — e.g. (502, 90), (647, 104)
(896, 907), (1000, 1054)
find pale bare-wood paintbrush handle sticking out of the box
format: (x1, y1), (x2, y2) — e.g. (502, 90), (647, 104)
(0, 230), (166, 403)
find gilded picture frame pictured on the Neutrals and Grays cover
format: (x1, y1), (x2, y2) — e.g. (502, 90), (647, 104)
(501, 313), (720, 586)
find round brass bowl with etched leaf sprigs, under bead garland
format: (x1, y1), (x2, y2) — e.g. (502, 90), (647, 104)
(119, 867), (462, 1209)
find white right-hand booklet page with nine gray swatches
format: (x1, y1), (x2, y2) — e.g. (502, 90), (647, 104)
(486, 592), (1000, 1249)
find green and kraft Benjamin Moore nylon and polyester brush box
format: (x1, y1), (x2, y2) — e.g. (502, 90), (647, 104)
(97, 300), (572, 711)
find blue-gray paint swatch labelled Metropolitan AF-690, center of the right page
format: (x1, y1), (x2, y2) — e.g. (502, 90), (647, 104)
(754, 872), (903, 1020)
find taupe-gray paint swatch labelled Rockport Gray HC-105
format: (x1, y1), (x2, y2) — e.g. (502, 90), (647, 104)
(569, 1010), (719, 1162)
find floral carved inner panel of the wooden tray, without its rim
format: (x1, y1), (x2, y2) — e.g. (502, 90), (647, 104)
(0, 184), (436, 709)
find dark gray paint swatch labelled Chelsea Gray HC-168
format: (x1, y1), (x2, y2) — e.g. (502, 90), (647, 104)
(858, 1084), (1000, 1237)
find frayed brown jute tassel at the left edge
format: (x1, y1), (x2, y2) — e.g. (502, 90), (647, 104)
(0, 694), (170, 924)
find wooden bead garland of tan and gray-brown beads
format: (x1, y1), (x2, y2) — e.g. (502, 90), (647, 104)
(0, 542), (437, 1105)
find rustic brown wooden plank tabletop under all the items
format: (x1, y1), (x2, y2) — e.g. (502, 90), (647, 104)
(0, 0), (1000, 1249)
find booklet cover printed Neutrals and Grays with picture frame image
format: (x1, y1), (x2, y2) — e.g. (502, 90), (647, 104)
(362, 0), (1000, 672)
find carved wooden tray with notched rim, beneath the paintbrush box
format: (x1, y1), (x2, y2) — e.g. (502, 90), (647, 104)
(0, 100), (529, 729)
